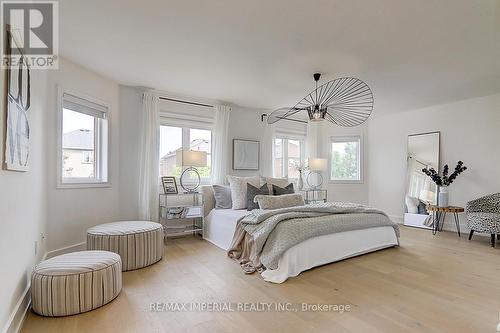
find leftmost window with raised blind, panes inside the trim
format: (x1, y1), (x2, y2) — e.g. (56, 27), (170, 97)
(58, 92), (108, 187)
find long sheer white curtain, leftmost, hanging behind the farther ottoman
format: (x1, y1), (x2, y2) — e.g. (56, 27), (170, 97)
(139, 92), (160, 221)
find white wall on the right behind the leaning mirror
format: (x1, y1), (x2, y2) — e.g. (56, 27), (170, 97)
(367, 94), (500, 230)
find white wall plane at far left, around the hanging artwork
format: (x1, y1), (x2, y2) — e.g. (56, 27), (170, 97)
(0, 70), (48, 329)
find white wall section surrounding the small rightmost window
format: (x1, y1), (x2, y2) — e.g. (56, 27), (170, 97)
(318, 121), (371, 204)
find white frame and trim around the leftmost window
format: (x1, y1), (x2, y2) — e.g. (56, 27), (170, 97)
(56, 87), (111, 189)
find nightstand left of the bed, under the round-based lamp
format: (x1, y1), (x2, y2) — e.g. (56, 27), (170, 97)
(158, 192), (205, 238)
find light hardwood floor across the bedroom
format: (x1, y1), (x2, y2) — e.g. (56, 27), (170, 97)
(22, 227), (500, 333)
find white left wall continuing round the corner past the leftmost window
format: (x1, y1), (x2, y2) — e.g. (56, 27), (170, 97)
(0, 58), (120, 330)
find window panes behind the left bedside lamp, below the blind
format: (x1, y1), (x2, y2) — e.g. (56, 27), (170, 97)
(159, 126), (212, 181)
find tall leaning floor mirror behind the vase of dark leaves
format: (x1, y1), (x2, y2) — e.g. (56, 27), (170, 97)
(404, 132), (440, 229)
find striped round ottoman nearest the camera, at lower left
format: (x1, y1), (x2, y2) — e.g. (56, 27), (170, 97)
(31, 251), (122, 317)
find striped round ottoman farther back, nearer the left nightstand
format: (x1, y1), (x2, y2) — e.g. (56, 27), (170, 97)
(87, 221), (163, 271)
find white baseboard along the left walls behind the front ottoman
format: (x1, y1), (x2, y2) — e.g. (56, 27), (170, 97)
(2, 242), (86, 333)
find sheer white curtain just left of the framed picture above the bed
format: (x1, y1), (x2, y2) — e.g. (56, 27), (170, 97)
(212, 105), (231, 184)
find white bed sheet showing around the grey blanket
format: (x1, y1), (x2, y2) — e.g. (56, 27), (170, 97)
(199, 184), (399, 283)
